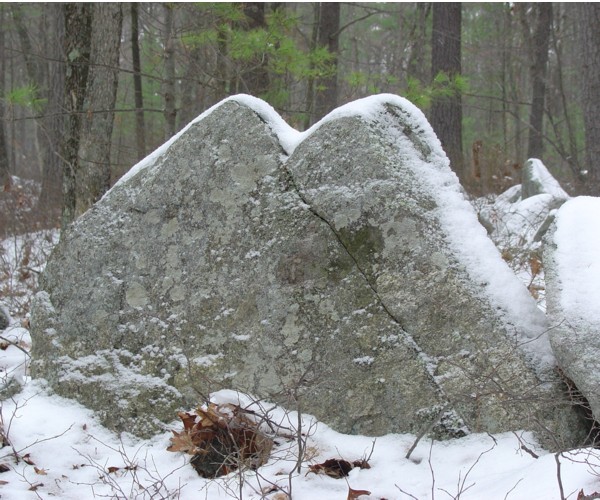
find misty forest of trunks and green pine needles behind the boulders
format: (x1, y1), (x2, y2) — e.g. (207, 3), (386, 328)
(0, 2), (600, 234)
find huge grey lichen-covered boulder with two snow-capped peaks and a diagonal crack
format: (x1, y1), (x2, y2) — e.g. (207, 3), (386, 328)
(32, 96), (581, 444)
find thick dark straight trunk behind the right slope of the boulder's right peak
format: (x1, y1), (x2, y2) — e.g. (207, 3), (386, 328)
(431, 3), (466, 181)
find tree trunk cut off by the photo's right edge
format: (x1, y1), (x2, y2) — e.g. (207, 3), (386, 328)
(576, 3), (600, 196)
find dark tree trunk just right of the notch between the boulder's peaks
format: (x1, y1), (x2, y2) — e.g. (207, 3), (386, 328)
(315, 2), (340, 120)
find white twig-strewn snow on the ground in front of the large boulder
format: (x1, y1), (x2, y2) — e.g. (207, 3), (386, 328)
(0, 382), (600, 500)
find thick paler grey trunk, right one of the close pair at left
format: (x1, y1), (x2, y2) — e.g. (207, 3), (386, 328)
(76, 3), (123, 215)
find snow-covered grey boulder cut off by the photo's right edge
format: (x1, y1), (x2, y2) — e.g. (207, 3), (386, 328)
(544, 196), (600, 421)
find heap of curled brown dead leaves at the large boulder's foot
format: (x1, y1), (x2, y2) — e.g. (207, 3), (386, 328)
(167, 403), (273, 478)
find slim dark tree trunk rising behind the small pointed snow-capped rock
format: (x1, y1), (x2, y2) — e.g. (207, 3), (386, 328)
(527, 3), (552, 158)
